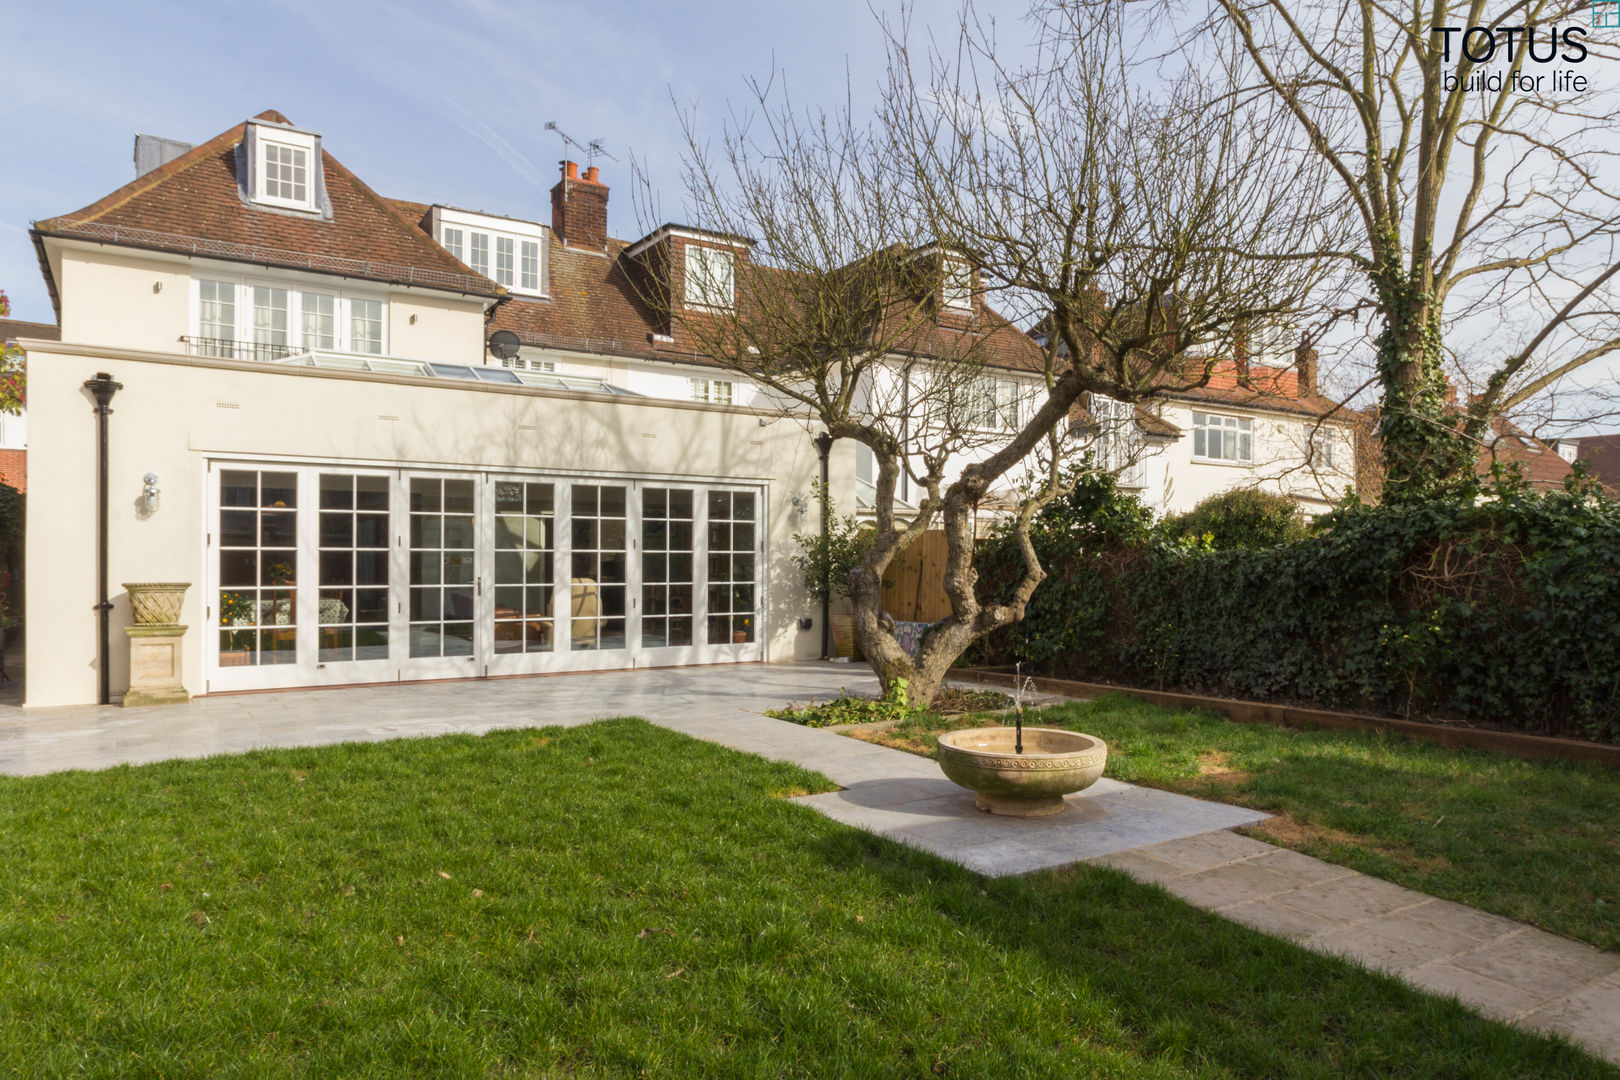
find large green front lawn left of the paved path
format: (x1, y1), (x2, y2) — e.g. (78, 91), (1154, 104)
(0, 721), (1620, 1080)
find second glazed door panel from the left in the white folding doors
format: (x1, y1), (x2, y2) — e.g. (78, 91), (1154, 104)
(316, 473), (390, 664)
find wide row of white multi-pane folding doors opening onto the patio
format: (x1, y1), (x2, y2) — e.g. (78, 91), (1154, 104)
(206, 461), (763, 691)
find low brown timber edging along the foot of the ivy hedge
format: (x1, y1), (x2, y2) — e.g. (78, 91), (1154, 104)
(951, 667), (1620, 769)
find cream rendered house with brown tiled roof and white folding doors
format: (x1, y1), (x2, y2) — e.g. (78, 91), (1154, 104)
(19, 112), (1037, 706)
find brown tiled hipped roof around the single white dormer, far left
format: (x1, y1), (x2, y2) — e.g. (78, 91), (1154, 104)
(34, 110), (505, 318)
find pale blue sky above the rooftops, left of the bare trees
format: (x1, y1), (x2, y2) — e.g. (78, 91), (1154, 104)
(0, 0), (1024, 321)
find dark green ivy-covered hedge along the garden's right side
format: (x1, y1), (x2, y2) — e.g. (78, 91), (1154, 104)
(978, 483), (1620, 742)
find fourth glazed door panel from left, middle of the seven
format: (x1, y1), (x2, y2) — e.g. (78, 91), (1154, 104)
(494, 481), (556, 653)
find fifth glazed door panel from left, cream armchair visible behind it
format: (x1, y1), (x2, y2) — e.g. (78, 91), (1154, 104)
(569, 484), (629, 649)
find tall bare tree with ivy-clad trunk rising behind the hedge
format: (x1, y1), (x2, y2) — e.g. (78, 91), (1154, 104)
(1198, 0), (1620, 497)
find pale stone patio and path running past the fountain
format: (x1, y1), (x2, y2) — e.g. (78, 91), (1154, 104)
(0, 664), (1620, 1064)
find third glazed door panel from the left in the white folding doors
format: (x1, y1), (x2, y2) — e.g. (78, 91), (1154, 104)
(410, 476), (476, 656)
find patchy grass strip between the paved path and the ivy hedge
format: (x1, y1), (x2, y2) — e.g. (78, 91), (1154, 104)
(862, 695), (1620, 949)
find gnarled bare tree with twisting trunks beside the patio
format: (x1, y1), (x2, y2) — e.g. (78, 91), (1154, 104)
(638, 0), (1333, 704)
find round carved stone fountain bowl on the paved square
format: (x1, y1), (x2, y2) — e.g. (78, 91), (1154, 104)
(938, 727), (1108, 818)
